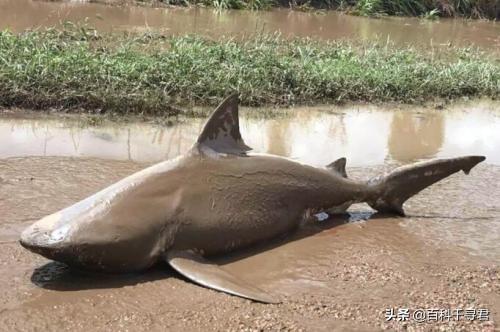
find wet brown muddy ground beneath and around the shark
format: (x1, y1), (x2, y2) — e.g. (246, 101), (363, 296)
(0, 157), (500, 331)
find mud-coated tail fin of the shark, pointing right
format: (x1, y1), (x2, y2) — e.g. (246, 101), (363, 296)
(367, 156), (486, 216)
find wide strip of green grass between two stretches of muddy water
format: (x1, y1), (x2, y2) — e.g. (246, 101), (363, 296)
(0, 27), (500, 115)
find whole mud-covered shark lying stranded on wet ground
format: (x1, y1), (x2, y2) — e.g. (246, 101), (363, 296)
(20, 95), (485, 303)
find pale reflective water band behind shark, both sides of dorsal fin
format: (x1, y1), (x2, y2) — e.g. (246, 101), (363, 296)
(0, 101), (500, 166)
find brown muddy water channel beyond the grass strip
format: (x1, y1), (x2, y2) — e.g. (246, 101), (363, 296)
(0, 0), (500, 51)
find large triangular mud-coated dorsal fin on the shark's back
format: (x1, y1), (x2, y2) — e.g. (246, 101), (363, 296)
(197, 93), (251, 155)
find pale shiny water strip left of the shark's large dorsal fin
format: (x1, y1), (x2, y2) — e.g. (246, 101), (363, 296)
(0, 119), (200, 161)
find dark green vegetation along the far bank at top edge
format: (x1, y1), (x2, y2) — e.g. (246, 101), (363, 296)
(146, 0), (500, 19)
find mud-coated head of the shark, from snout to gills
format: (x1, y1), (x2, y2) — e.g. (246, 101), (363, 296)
(19, 175), (175, 272)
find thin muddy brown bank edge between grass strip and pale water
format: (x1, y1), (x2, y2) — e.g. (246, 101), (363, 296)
(0, 97), (500, 126)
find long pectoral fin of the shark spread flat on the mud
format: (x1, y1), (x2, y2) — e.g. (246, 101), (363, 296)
(166, 250), (279, 303)
